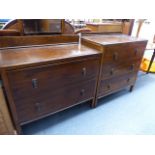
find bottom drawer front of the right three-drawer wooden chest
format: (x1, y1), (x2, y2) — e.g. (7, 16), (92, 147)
(98, 73), (137, 97)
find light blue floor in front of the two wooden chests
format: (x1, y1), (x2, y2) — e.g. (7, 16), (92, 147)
(23, 69), (155, 135)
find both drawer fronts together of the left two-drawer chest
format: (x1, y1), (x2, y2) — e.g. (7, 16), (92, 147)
(8, 56), (99, 124)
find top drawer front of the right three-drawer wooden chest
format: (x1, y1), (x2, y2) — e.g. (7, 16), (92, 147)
(103, 43), (146, 63)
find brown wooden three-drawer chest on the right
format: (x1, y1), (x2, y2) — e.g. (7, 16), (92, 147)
(83, 34), (147, 107)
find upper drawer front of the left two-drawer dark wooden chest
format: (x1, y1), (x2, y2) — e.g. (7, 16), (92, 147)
(8, 58), (99, 99)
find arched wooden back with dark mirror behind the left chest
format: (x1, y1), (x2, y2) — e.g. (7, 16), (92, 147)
(3, 19), (74, 35)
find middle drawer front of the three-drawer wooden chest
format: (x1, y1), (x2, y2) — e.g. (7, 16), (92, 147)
(101, 60), (141, 80)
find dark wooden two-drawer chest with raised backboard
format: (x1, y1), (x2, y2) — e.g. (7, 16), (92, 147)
(0, 36), (101, 133)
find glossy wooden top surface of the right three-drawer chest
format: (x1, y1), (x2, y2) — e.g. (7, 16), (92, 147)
(82, 34), (147, 45)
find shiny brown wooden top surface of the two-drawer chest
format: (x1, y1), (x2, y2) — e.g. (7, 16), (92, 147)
(0, 44), (100, 70)
